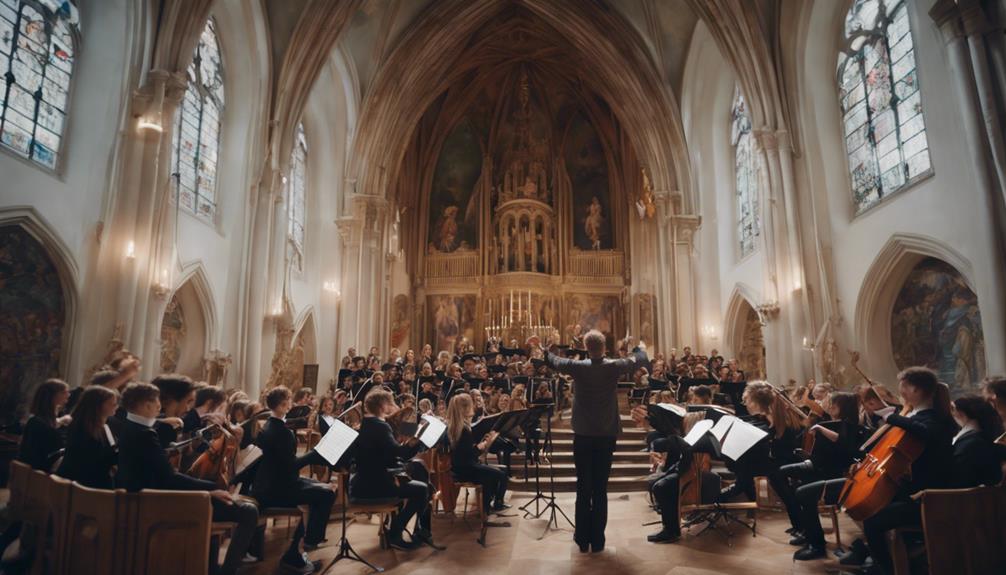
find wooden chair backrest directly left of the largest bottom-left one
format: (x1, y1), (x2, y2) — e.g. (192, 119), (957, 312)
(59, 483), (129, 575)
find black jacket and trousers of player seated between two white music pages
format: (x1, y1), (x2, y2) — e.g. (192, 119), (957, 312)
(349, 416), (431, 538)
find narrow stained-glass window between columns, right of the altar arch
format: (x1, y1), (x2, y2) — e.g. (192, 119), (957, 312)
(730, 88), (762, 257)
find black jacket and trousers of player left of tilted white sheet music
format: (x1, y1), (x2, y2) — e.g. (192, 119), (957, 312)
(252, 416), (335, 549)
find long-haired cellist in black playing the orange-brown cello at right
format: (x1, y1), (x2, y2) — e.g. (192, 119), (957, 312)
(843, 367), (956, 573)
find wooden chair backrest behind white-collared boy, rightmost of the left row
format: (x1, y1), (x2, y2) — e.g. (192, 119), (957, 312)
(125, 490), (212, 575)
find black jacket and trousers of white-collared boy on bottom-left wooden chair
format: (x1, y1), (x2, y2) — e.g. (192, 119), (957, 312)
(116, 419), (259, 574)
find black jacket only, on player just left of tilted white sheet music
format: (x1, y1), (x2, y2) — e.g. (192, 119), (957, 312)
(252, 416), (311, 502)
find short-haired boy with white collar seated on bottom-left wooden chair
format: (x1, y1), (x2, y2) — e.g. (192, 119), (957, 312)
(116, 383), (259, 575)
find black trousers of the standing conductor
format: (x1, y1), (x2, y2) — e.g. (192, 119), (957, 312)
(572, 435), (615, 551)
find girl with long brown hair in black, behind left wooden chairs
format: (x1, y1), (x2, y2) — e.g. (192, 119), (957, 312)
(56, 385), (119, 490)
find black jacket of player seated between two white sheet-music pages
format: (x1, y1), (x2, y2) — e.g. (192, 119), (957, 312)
(349, 416), (421, 499)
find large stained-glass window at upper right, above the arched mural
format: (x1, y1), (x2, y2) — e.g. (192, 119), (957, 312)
(838, 0), (933, 213)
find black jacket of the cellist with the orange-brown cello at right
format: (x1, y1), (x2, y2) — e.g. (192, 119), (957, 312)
(887, 409), (957, 495)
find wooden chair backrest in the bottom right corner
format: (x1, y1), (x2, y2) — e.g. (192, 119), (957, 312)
(921, 487), (1006, 574)
